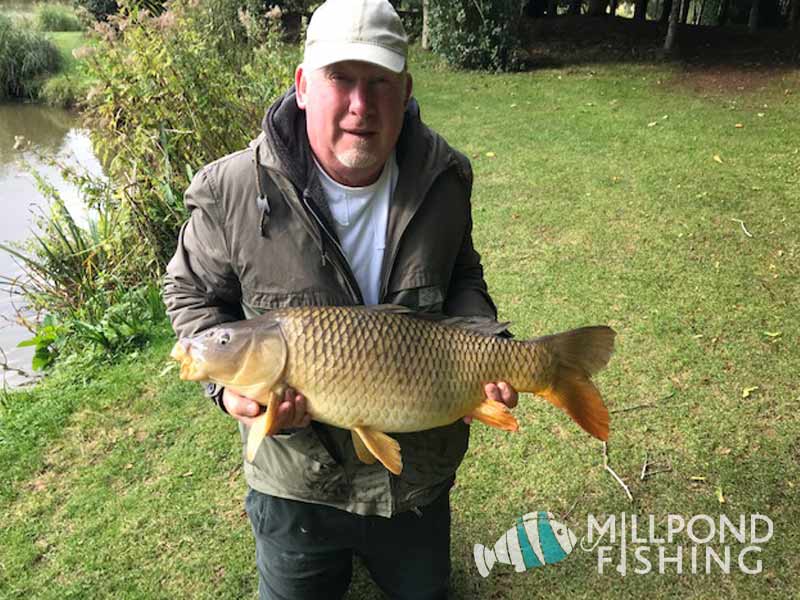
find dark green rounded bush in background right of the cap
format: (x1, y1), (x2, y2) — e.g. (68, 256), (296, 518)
(428, 0), (521, 71)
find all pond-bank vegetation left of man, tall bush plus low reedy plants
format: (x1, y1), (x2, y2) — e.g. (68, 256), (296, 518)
(0, 0), (299, 365)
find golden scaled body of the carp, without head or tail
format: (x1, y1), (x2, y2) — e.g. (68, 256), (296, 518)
(272, 308), (547, 432)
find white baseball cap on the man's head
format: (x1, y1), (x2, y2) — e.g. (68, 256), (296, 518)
(303, 0), (408, 73)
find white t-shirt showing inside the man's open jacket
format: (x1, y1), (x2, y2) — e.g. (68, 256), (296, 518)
(314, 152), (398, 304)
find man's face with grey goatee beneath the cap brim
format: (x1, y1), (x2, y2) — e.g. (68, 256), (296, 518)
(295, 61), (411, 187)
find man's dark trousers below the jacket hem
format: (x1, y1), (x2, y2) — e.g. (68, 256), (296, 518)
(246, 490), (450, 600)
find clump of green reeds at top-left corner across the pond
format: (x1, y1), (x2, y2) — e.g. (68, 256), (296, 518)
(0, 15), (61, 100)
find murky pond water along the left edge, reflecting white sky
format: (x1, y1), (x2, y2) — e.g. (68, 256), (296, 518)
(0, 104), (102, 386)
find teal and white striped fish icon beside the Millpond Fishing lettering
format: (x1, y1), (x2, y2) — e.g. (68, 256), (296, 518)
(473, 511), (577, 577)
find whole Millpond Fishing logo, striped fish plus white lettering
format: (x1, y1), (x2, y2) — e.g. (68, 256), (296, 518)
(473, 511), (774, 577)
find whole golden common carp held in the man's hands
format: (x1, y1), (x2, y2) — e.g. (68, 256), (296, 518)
(171, 305), (616, 474)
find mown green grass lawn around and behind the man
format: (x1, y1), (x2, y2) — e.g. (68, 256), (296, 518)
(0, 54), (800, 599)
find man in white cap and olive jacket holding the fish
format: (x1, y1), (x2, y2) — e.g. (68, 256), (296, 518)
(164, 0), (517, 599)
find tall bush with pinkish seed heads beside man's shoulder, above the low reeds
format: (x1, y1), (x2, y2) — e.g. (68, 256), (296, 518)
(85, 3), (294, 278)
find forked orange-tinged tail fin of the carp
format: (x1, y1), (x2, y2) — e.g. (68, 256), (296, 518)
(536, 326), (616, 441)
